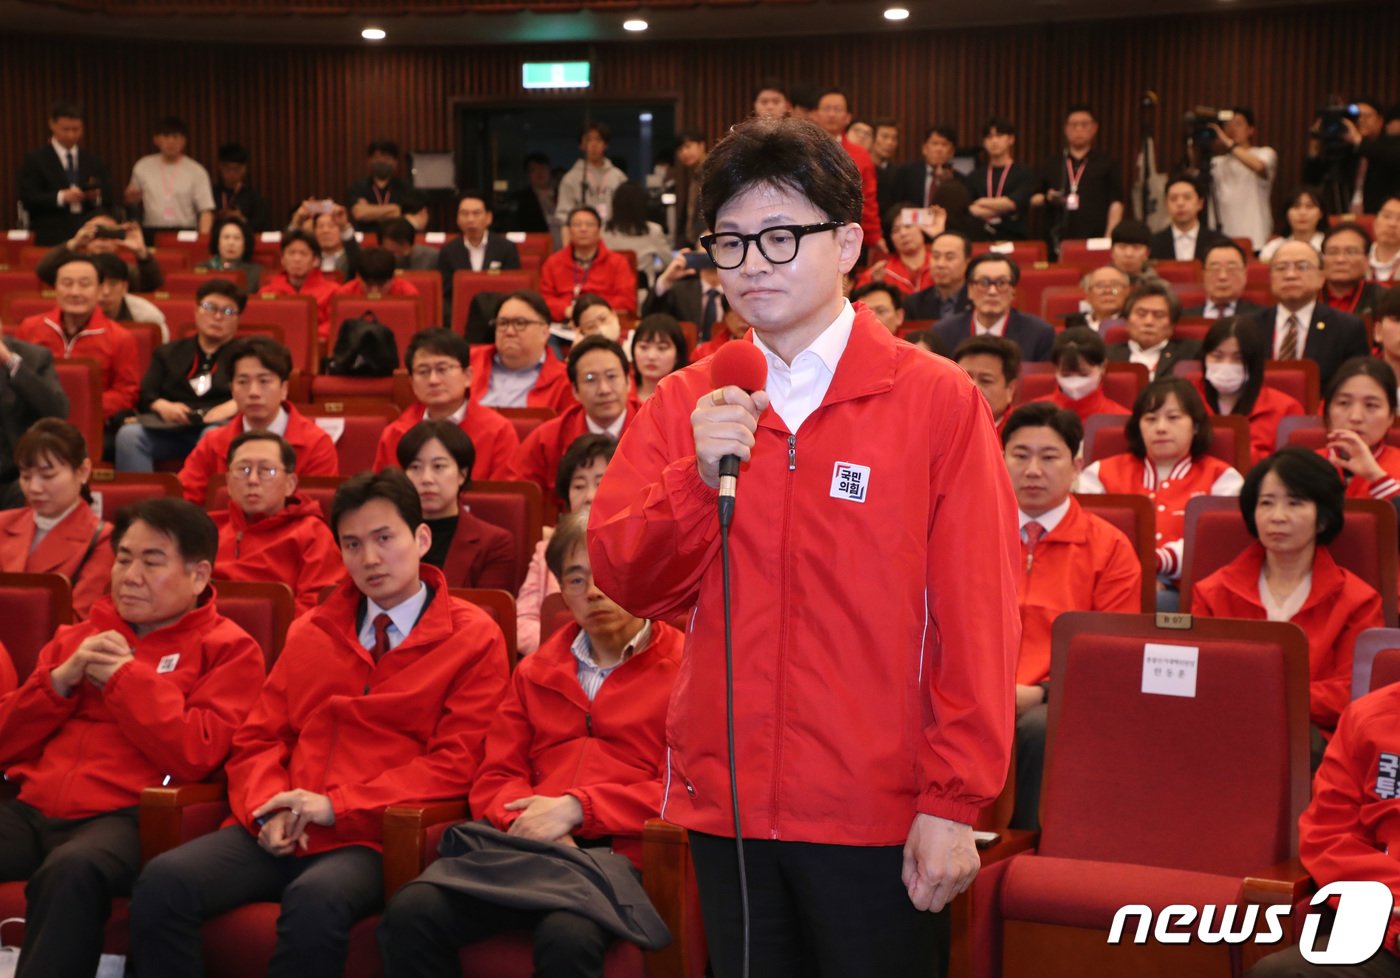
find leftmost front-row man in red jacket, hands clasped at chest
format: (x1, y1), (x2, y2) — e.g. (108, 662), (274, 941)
(0, 497), (263, 978)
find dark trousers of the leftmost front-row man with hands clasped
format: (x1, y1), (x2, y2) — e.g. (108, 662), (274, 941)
(0, 800), (141, 978)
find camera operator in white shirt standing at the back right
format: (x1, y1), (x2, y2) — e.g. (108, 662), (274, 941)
(1208, 106), (1278, 252)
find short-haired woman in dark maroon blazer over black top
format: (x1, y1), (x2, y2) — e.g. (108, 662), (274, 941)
(398, 420), (517, 590)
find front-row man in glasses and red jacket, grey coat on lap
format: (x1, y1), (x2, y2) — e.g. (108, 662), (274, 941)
(379, 515), (685, 978)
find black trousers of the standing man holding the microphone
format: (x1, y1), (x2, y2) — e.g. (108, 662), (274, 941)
(690, 832), (949, 978)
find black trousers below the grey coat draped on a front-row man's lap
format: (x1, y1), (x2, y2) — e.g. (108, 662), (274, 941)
(379, 881), (613, 978)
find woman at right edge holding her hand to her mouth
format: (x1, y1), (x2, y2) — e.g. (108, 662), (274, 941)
(1319, 357), (1400, 499)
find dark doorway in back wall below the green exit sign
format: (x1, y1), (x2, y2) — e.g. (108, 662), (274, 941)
(455, 98), (676, 229)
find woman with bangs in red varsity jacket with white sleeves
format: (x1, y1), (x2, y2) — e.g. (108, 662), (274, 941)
(1077, 376), (1245, 590)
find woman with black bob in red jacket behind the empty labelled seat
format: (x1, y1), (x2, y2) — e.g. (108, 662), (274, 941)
(1191, 448), (1385, 767)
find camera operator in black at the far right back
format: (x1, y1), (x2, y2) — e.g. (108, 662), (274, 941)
(1303, 98), (1400, 214)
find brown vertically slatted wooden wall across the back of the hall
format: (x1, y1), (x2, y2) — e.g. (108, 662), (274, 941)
(0, 3), (1400, 239)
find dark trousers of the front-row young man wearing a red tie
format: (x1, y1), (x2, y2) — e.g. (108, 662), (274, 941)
(132, 825), (384, 978)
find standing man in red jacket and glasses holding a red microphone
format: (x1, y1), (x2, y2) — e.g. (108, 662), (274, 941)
(588, 119), (1021, 978)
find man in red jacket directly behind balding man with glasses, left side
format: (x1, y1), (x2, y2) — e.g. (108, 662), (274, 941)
(179, 336), (340, 506)
